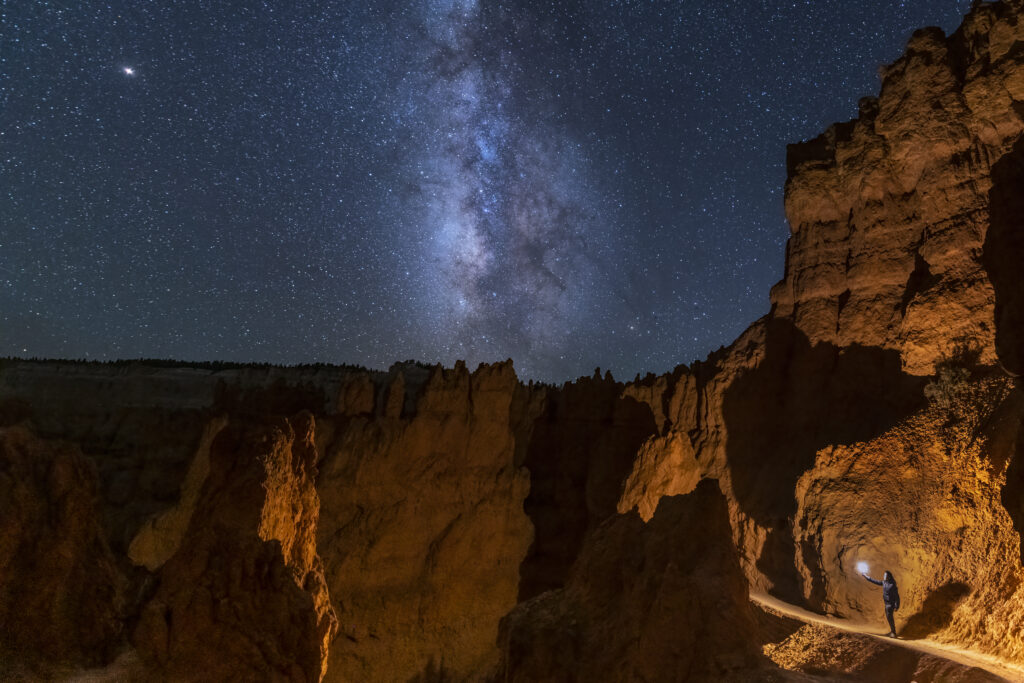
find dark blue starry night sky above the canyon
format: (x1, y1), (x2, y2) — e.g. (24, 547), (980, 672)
(0, 0), (970, 382)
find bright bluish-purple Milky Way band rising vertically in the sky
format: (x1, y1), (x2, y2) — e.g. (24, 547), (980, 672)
(401, 1), (625, 372)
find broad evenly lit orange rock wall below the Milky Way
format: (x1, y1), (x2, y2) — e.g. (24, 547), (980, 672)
(317, 362), (538, 681)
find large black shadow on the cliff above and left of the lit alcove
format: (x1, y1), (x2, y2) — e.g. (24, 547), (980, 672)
(723, 319), (923, 602)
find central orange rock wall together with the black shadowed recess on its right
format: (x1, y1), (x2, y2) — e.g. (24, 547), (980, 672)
(317, 362), (654, 681)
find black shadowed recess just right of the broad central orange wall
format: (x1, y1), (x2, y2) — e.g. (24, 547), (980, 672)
(519, 376), (657, 600)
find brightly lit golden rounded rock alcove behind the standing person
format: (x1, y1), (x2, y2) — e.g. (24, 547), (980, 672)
(796, 374), (1024, 660)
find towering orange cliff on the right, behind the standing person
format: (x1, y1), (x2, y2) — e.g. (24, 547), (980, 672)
(620, 2), (1024, 659)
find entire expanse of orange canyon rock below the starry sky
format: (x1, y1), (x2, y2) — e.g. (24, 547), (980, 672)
(0, 0), (1024, 682)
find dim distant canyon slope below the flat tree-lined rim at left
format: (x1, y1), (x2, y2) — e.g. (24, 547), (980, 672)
(0, 361), (368, 554)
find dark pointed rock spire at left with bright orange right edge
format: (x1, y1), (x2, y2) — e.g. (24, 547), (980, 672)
(132, 414), (337, 682)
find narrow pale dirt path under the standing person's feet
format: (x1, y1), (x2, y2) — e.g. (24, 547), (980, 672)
(751, 593), (1024, 683)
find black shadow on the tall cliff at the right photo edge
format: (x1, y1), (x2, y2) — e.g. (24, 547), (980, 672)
(982, 138), (1024, 376)
